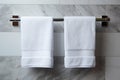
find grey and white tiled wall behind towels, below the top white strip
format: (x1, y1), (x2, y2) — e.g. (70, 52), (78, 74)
(0, 1), (120, 80)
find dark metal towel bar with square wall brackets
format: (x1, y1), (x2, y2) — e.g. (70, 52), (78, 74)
(10, 15), (110, 27)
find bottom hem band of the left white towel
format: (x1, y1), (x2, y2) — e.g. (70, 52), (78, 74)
(21, 57), (53, 68)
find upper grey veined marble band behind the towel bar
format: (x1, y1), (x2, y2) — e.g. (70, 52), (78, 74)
(0, 4), (120, 32)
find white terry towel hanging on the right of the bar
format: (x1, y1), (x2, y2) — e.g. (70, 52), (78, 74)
(64, 16), (95, 68)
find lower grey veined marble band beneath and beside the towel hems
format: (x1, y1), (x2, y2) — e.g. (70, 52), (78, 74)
(0, 56), (105, 80)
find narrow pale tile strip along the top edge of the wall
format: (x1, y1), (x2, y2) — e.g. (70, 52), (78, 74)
(0, 0), (120, 5)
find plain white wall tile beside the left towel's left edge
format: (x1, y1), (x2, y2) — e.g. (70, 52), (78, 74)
(0, 32), (21, 56)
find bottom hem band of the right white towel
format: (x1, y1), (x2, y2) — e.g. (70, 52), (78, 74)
(64, 56), (95, 68)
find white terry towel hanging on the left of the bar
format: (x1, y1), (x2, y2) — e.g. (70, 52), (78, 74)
(21, 16), (53, 68)
